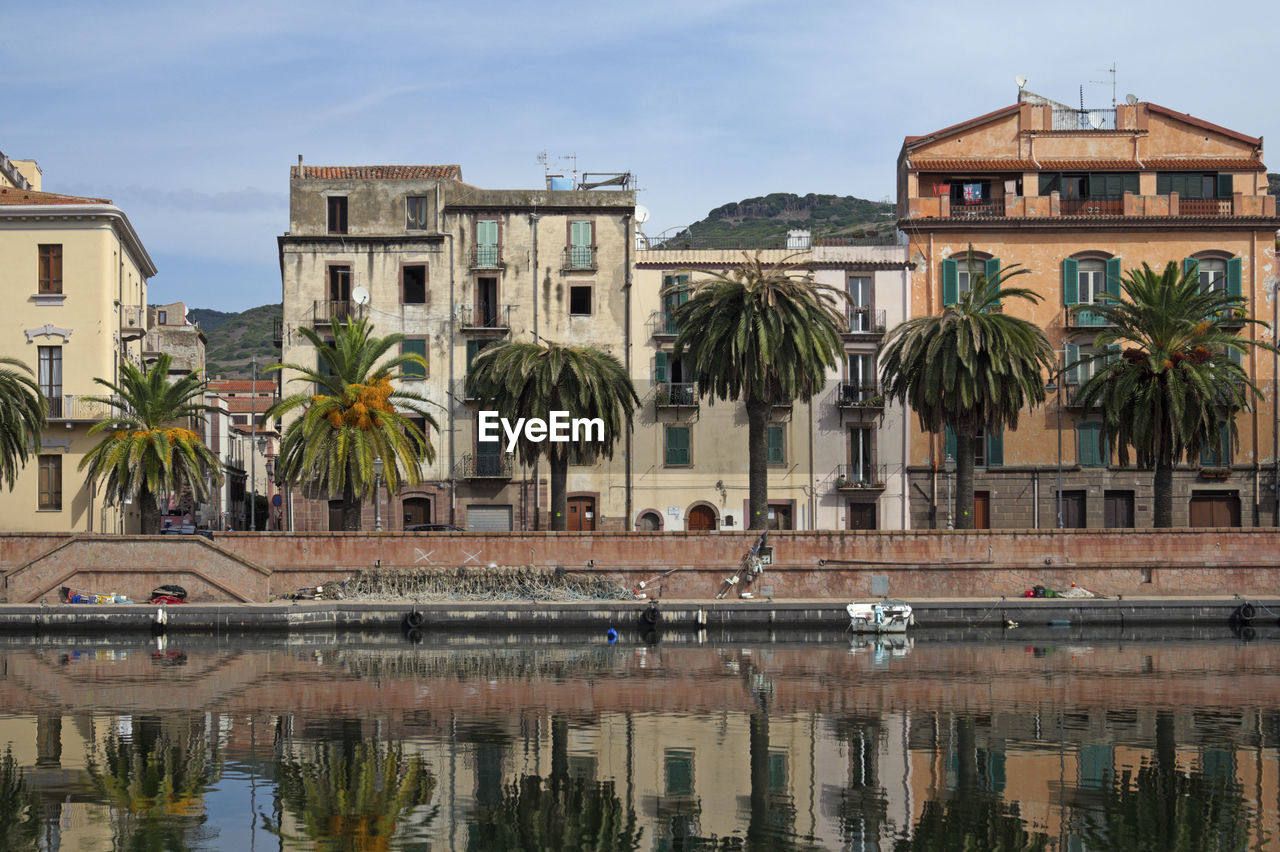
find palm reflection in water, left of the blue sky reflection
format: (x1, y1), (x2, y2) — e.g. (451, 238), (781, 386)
(88, 716), (221, 849)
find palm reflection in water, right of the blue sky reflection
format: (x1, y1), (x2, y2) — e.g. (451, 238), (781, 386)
(278, 721), (435, 852)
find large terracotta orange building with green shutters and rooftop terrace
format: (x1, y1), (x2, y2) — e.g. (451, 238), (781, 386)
(897, 91), (1280, 528)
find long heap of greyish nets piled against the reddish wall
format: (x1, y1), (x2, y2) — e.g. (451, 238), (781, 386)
(335, 565), (634, 601)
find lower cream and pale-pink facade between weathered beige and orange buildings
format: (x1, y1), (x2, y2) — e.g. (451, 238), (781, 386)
(631, 233), (909, 530)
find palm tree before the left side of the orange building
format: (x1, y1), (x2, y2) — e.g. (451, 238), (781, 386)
(881, 249), (1053, 530)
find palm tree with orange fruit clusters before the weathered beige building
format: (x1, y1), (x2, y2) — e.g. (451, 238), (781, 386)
(262, 317), (436, 530)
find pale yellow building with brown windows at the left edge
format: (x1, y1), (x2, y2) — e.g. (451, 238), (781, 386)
(0, 156), (156, 532)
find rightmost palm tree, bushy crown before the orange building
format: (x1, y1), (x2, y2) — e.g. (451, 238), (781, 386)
(1066, 262), (1274, 527)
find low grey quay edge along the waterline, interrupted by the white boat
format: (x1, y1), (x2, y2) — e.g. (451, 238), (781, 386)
(0, 596), (1280, 635)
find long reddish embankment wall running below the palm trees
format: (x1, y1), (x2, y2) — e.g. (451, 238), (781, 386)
(0, 530), (1280, 603)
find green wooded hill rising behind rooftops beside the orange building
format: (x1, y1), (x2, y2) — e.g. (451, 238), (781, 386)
(655, 192), (895, 248)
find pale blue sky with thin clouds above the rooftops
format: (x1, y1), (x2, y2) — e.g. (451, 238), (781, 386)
(0, 0), (1280, 311)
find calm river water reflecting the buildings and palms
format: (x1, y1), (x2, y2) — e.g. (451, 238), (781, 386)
(0, 628), (1280, 852)
